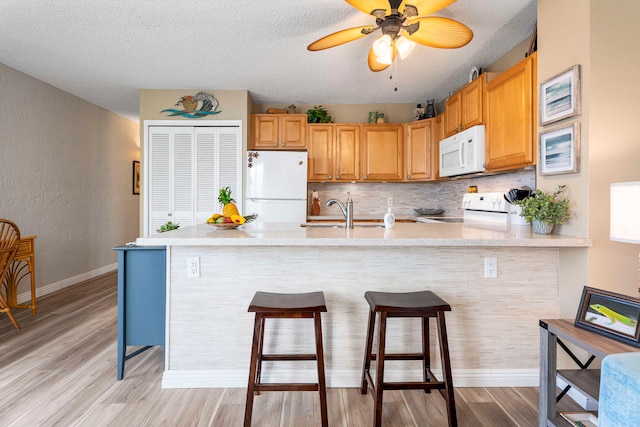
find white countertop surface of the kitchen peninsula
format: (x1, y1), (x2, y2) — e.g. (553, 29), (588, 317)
(136, 223), (593, 247)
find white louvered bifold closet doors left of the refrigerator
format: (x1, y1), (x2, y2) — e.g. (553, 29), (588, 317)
(145, 126), (244, 234)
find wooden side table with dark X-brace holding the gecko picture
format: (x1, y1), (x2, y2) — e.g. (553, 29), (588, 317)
(538, 319), (640, 427)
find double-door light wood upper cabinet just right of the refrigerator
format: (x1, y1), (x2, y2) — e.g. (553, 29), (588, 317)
(307, 124), (362, 182)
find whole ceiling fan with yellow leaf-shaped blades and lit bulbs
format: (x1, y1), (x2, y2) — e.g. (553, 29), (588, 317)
(307, 0), (473, 71)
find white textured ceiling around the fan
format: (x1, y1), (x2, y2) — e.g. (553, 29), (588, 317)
(0, 0), (537, 120)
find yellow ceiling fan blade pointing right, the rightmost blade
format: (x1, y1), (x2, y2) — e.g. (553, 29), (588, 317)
(403, 16), (473, 49)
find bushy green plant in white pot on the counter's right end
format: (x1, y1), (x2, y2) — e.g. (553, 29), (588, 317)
(514, 185), (569, 234)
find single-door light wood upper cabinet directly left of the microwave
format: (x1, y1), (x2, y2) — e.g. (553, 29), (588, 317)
(404, 118), (436, 181)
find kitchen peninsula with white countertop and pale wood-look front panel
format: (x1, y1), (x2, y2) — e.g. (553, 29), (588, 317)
(137, 223), (592, 388)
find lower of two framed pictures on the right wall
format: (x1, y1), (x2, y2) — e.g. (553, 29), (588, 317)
(538, 122), (580, 175)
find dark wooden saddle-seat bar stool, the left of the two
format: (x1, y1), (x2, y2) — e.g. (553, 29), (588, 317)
(244, 292), (328, 427)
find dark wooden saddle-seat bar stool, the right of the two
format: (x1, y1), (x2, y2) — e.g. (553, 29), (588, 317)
(360, 291), (458, 427)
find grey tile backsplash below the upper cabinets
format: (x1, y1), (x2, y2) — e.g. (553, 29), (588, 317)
(307, 170), (536, 218)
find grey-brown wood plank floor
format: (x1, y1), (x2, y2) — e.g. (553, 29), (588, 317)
(0, 273), (579, 427)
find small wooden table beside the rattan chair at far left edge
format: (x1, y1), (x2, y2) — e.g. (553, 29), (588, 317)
(4, 236), (37, 316)
